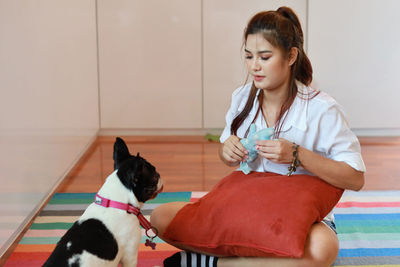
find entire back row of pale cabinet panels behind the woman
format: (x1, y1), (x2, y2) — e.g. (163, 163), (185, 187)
(98, 0), (400, 133)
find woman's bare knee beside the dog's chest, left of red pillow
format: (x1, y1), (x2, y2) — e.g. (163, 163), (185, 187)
(150, 202), (188, 236)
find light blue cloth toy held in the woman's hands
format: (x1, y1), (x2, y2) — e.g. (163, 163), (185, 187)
(239, 123), (274, 174)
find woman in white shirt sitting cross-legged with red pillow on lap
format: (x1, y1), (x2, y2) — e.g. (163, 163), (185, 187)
(152, 7), (365, 267)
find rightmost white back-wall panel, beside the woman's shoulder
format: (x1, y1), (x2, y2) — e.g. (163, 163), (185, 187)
(308, 0), (400, 135)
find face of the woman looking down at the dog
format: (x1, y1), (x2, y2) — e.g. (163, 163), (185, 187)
(245, 33), (291, 91)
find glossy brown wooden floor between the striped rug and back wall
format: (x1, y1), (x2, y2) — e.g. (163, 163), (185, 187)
(57, 136), (400, 192)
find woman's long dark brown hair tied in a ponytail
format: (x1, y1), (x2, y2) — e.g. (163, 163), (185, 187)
(231, 7), (312, 138)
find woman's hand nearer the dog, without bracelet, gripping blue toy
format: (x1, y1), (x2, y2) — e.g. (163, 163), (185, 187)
(220, 135), (248, 166)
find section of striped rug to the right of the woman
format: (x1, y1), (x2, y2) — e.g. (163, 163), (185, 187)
(334, 191), (400, 267)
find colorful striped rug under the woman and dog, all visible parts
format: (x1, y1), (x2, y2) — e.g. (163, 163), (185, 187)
(5, 191), (400, 267)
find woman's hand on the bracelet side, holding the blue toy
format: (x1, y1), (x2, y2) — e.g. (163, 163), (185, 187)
(256, 138), (293, 163)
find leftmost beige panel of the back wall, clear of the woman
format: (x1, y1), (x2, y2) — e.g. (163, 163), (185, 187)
(98, 0), (202, 129)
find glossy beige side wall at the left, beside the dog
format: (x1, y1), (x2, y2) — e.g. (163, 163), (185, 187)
(0, 0), (99, 255)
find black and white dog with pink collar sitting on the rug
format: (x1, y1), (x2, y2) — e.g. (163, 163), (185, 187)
(43, 138), (162, 267)
